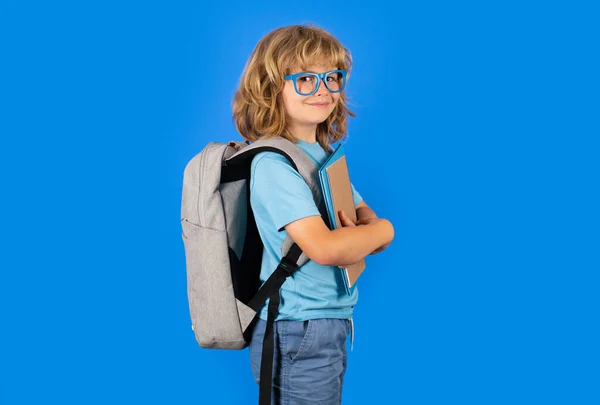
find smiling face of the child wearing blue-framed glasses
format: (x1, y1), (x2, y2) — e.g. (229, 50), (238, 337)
(283, 65), (341, 133)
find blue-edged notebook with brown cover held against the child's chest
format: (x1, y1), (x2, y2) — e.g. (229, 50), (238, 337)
(319, 144), (366, 294)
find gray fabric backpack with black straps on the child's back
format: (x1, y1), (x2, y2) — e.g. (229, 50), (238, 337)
(181, 138), (328, 405)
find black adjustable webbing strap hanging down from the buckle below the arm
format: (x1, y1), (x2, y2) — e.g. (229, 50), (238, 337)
(249, 243), (302, 405)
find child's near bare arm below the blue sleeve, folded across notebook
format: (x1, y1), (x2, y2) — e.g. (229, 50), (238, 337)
(285, 216), (394, 266)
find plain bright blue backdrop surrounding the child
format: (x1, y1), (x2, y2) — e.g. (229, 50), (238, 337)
(0, 0), (600, 405)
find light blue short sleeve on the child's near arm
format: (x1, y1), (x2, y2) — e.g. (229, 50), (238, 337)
(250, 152), (321, 231)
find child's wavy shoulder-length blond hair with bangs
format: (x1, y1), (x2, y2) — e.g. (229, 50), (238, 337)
(233, 25), (356, 150)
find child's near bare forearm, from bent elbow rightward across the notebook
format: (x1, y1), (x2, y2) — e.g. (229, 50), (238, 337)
(327, 220), (394, 266)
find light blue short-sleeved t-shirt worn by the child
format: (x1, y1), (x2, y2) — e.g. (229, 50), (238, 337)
(250, 140), (362, 321)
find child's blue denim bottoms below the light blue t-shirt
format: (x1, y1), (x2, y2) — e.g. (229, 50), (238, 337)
(250, 318), (350, 405)
